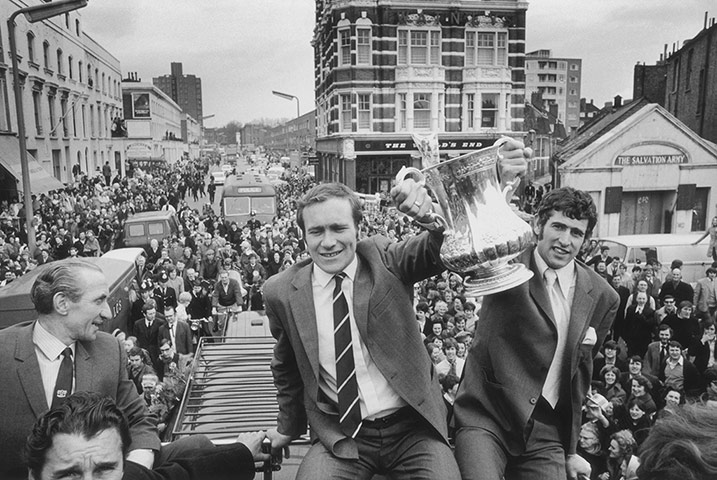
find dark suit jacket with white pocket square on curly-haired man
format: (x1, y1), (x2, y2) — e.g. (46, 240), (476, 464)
(454, 249), (619, 454)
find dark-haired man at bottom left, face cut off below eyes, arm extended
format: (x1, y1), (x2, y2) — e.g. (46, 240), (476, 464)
(20, 392), (268, 480)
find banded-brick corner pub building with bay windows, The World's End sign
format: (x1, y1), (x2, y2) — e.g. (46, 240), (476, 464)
(312, 0), (528, 193)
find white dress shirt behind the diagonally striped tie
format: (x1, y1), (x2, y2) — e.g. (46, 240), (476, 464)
(311, 257), (406, 420)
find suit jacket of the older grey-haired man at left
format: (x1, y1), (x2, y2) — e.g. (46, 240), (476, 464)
(0, 322), (160, 480)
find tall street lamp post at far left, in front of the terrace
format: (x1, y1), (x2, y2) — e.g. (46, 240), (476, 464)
(7, 0), (87, 255)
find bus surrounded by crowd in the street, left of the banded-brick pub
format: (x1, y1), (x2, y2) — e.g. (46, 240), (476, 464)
(219, 173), (276, 225)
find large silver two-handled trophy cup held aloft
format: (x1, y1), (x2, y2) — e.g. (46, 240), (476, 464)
(396, 138), (533, 296)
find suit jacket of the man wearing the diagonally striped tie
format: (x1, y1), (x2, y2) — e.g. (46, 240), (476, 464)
(264, 232), (448, 458)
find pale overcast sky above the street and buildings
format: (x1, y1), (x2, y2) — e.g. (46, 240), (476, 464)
(79, 0), (717, 127)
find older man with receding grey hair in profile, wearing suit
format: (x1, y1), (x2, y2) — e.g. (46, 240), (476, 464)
(0, 259), (160, 479)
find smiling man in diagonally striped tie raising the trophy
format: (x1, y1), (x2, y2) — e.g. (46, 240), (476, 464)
(264, 141), (528, 480)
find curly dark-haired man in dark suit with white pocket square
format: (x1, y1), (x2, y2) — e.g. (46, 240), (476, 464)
(454, 187), (620, 480)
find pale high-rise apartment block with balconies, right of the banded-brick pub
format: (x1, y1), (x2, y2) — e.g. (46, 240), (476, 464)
(525, 50), (583, 133)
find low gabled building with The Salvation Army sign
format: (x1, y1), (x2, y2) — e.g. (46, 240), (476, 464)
(552, 99), (717, 236)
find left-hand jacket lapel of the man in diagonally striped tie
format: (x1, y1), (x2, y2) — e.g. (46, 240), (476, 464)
(289, 262), (319, 380)
